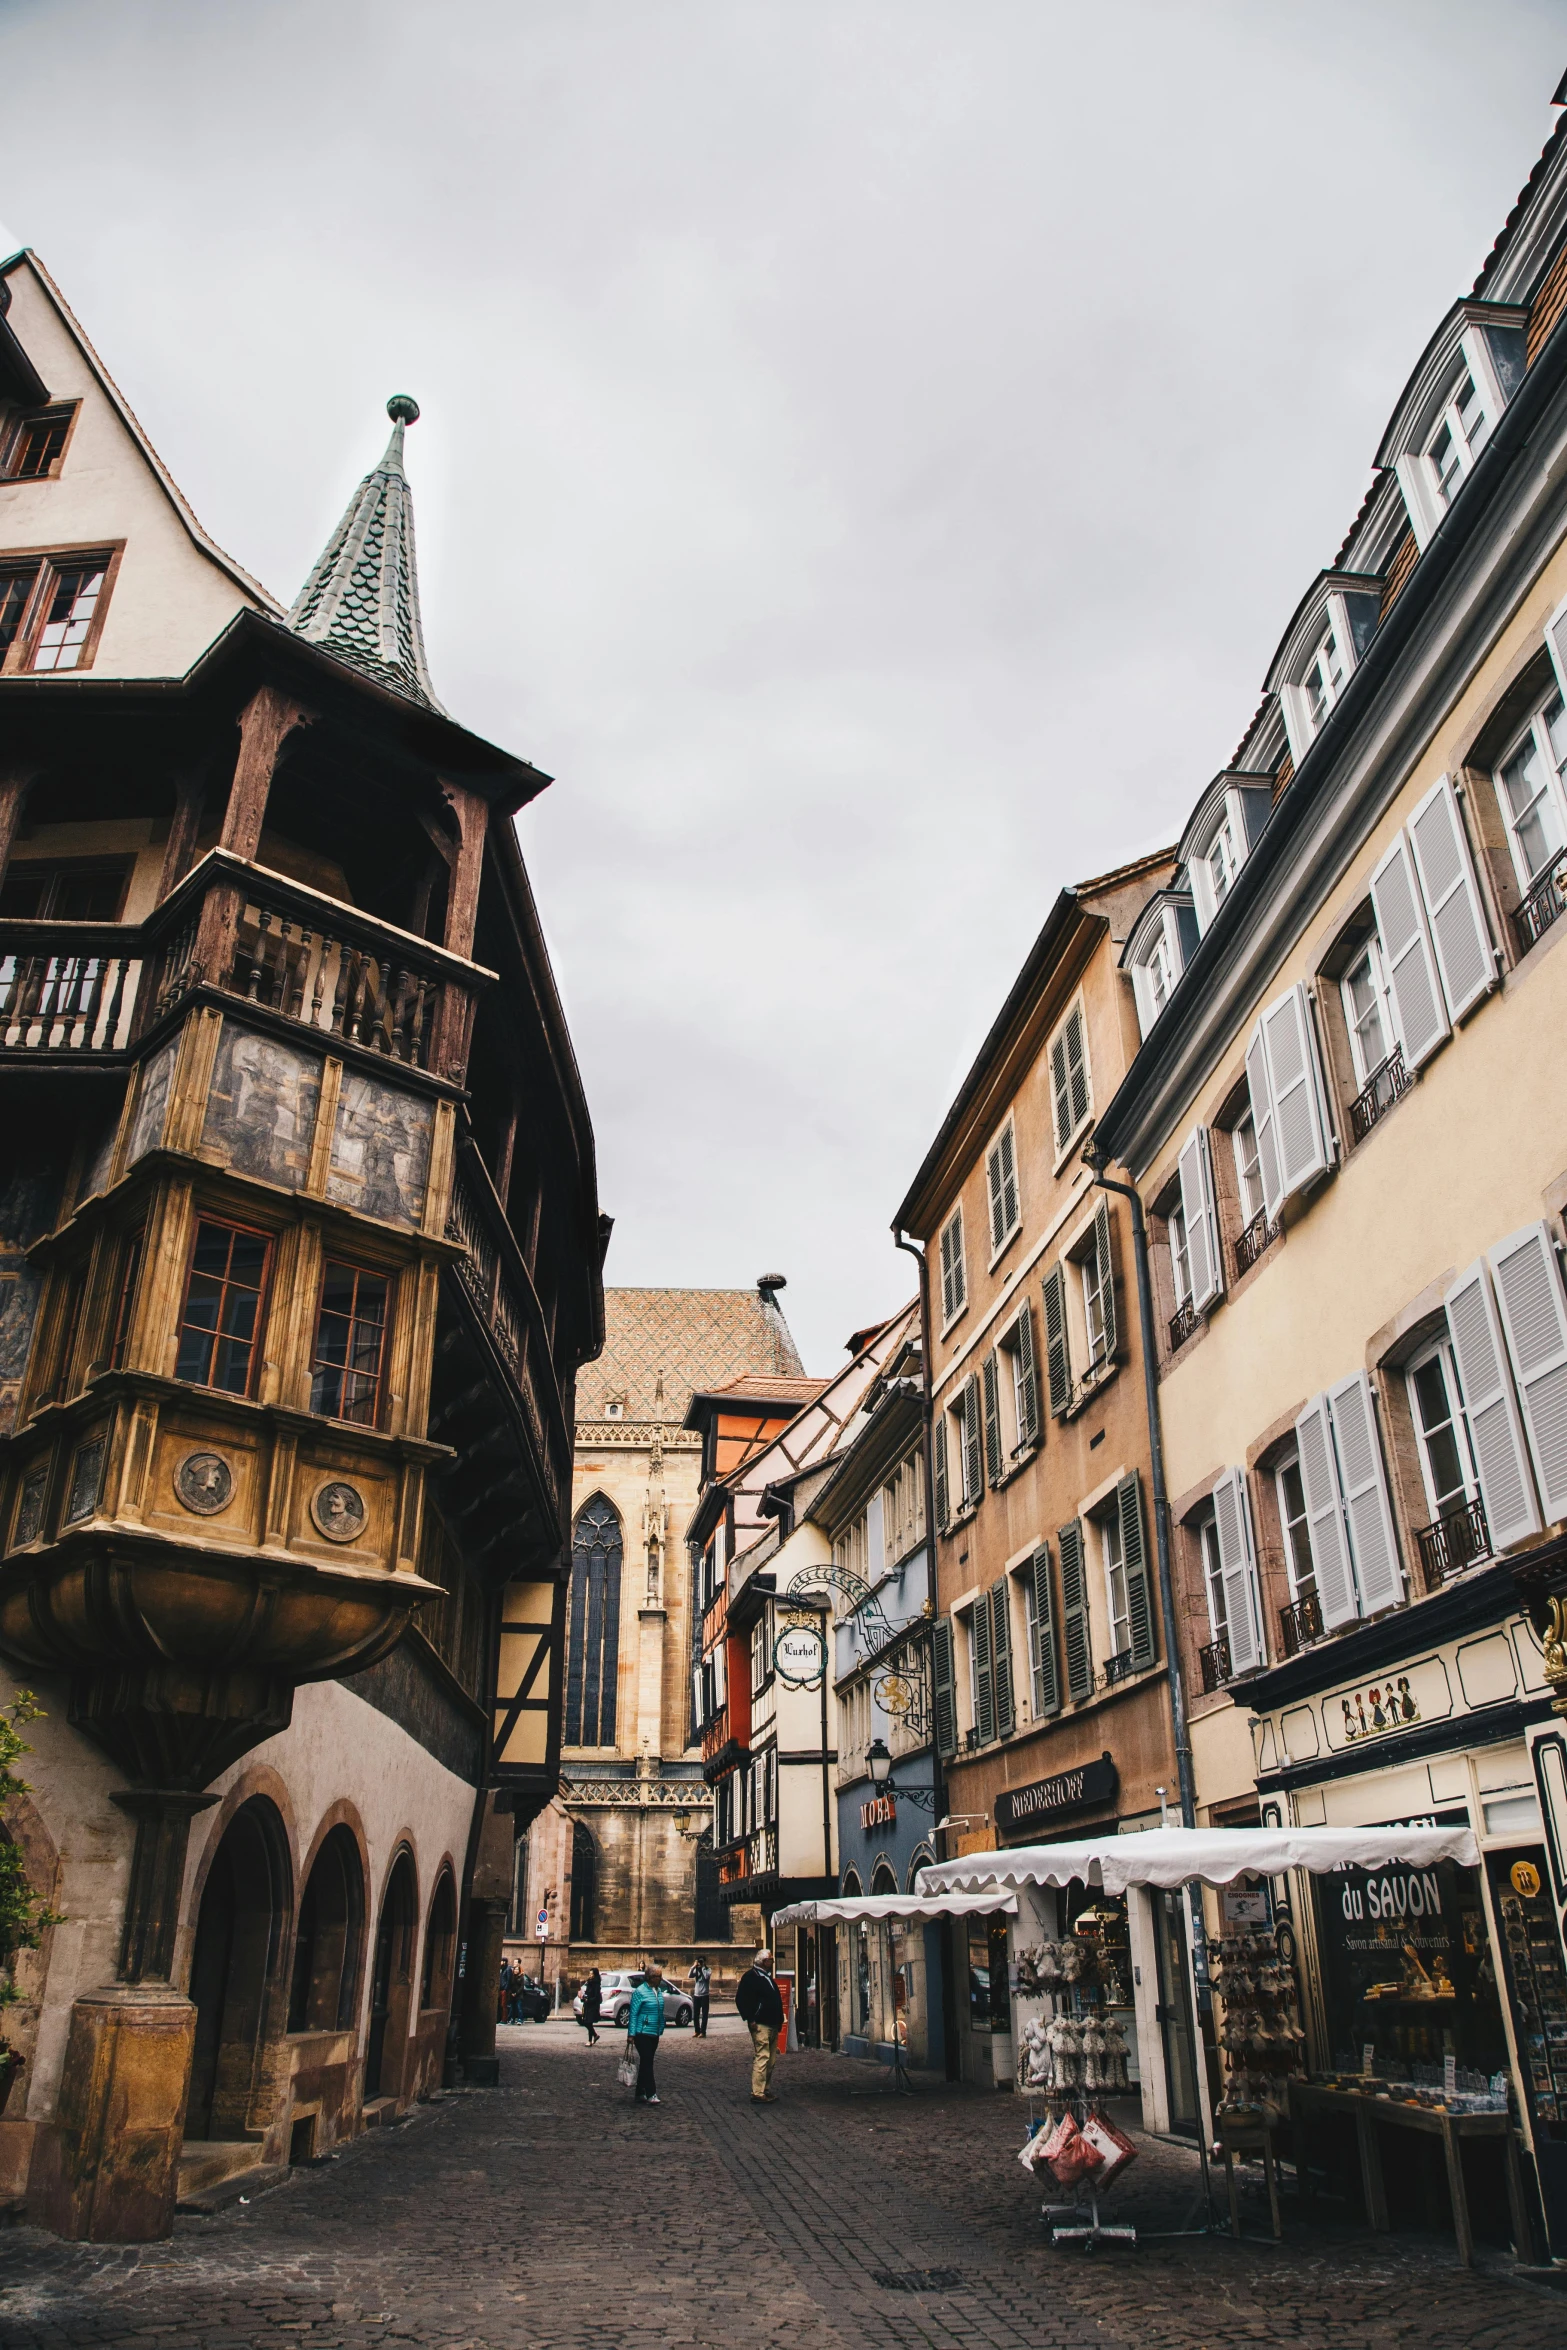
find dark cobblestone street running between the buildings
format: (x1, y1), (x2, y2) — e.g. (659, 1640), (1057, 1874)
(0, 2016), (1567, 2350)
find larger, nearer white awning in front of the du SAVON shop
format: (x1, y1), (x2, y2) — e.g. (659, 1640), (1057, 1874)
(919, 1828), (1480, 1904)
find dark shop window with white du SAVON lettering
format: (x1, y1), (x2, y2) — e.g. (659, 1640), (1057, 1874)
(1311, 1861), (1508, 2089)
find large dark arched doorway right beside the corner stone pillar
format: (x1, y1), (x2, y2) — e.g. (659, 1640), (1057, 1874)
(186, 1795), (291, 2139)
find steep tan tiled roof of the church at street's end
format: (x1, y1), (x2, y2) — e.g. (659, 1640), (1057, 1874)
(576, 1290), (803, 1426)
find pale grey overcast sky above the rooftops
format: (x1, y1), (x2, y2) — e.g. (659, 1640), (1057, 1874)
(0, 0), (1567, 1370)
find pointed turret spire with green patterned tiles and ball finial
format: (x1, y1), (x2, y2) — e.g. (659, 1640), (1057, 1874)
(289, 392), (442, 710)
